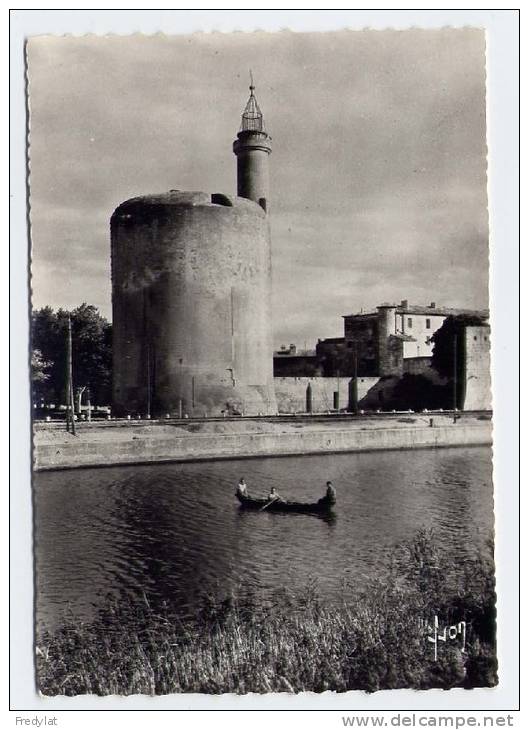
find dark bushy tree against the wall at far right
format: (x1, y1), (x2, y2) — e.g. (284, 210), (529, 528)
(432, 314), (485, 408)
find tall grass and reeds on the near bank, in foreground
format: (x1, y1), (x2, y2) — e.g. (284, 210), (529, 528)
(37, 530), (497, 695)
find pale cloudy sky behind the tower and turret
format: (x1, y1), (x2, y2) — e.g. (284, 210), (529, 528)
(27, 28), (488, 347)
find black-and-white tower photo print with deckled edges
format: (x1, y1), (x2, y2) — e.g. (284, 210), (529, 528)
(9, 7), (514, 706)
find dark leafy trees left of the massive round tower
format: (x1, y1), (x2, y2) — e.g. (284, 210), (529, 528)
(32, 303), (112, 410)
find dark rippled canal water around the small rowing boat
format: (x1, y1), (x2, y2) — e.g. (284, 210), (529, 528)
(35, 447), (493, 628)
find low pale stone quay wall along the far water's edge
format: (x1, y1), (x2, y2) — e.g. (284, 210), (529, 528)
(34, 414), (492, 470)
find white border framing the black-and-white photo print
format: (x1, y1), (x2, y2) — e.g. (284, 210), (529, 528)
(9, 9), (519, 716)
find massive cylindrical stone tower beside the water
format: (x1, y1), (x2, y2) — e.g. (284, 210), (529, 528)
(111, 83), (276, 417)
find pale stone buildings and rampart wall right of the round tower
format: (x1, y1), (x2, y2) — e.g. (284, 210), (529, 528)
(274, 300), (491, 412)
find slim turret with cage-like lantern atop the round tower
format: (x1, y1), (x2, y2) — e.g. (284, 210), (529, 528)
(233, 80), (272, 211)
